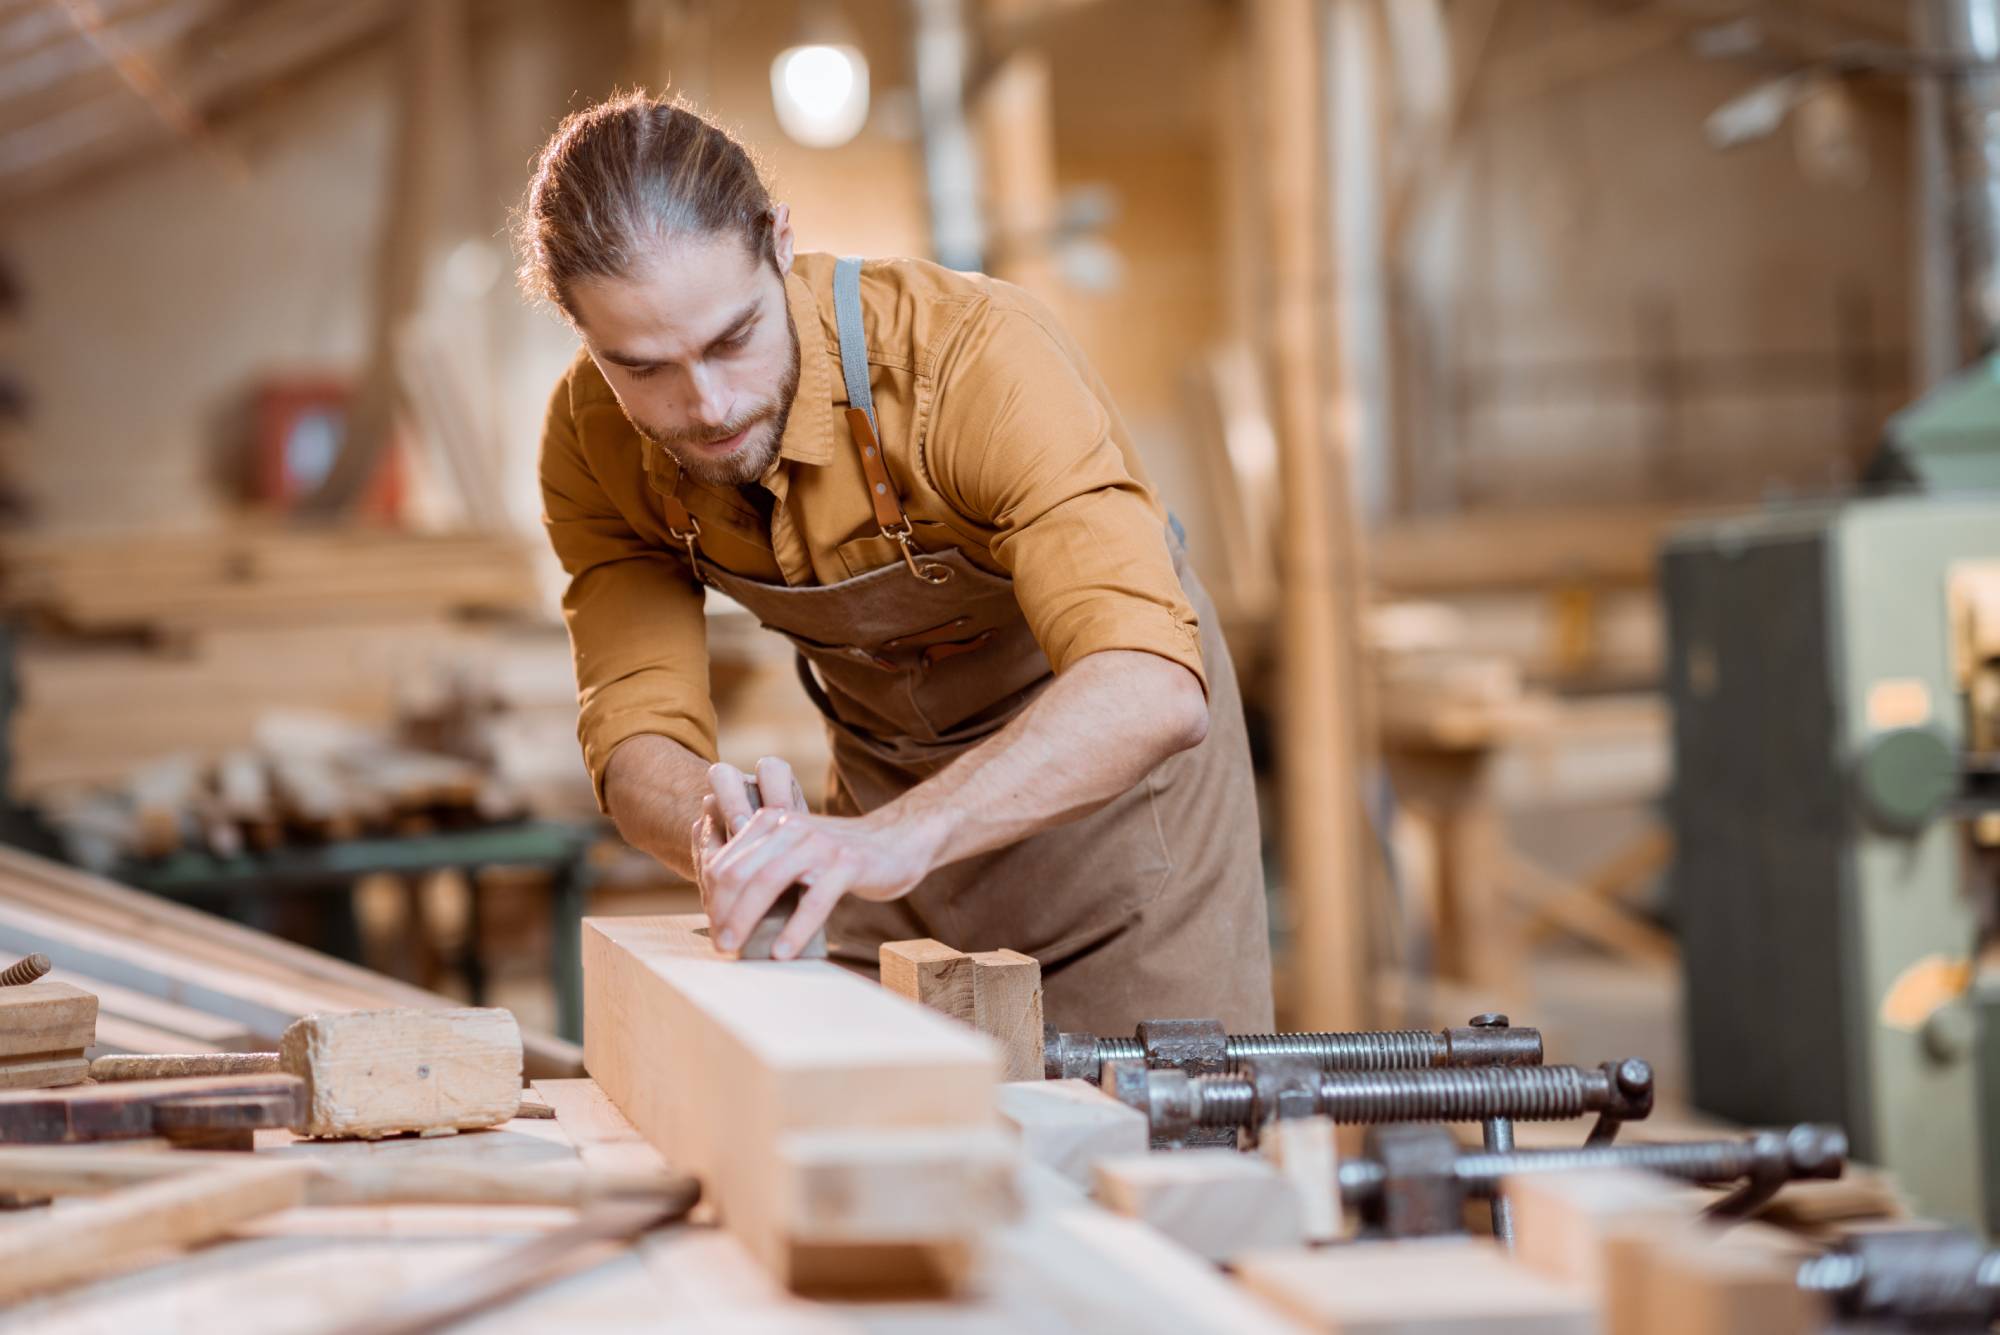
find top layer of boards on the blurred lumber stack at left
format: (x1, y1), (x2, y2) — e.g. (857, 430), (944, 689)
(0, 528), (538, 638)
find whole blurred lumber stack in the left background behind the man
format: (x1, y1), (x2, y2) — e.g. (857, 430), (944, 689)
(0, 530), (574, 801)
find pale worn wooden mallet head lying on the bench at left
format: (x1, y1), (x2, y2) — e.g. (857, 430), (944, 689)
(278, 1007), (520, 1139)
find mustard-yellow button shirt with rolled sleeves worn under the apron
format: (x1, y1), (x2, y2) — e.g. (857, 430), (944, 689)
(540, 254), (1202, 803)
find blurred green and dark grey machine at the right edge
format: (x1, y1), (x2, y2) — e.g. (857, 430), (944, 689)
(1662, 351), (2000, 1233)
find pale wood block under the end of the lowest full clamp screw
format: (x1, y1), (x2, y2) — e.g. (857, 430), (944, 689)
(1506, 1169), (1698, 1297)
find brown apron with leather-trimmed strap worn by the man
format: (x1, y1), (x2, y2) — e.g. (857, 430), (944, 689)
(662, 259), (1272, 1033)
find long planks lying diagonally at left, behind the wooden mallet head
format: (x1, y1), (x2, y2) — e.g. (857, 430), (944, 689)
(0, 847), (582, 1075)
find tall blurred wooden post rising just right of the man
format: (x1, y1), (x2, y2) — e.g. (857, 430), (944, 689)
(1250, 0), (1368, 1029)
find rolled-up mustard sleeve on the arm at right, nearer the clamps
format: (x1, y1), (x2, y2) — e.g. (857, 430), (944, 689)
(926, 310), (1208, 689)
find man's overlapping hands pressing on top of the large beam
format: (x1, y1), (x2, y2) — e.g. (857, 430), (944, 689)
(692, 755), (936, 959)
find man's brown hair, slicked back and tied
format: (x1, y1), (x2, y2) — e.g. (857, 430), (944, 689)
(516, 90), (774, 312)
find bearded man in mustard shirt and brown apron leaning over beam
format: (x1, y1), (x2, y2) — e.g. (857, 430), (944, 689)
(520, 94), (1270, 1031)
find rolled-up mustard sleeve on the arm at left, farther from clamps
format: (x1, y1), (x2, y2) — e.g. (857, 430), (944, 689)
(540, 382), (716, 809)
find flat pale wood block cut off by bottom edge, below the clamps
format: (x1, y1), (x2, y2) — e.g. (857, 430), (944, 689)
(1236, 1237), (1598, 1335)
